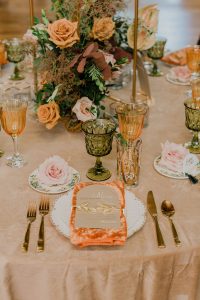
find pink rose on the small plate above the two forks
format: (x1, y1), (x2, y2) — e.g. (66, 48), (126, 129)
(38, 155), (72, 186)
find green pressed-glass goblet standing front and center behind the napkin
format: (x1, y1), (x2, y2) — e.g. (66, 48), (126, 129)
(82, 119), (116, 181)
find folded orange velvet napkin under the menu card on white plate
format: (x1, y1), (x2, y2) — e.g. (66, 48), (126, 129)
(70, 181), (127, 247)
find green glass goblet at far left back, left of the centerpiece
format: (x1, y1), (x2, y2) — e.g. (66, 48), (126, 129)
(5, 38), (25, 80)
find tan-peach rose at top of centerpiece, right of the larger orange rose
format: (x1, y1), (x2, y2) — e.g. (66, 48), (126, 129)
(91, 17), (115, 41)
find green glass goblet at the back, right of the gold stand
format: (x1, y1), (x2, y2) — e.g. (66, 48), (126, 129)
(147, 38), (167, 76)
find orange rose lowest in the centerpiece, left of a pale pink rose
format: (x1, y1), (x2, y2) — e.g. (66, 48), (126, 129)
(37, 101), (60, 129)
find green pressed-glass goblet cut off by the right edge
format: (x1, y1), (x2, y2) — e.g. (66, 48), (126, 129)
(184, 99), (200, 154)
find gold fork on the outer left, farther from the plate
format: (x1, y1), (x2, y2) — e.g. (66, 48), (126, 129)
(22, 202), (36, 252)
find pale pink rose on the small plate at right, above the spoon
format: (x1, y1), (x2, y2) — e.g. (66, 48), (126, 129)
(159, 141), (189, 173)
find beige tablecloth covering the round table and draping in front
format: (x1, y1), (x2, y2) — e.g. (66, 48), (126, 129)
(0, 63), (200, 300)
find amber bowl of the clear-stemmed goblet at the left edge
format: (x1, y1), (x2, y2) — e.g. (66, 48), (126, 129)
(1, 107), (26, 136)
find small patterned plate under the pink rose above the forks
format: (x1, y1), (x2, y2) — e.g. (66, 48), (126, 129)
(28, 167), (80, 194)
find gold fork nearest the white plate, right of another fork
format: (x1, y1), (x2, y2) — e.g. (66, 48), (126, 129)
(37, 196), (49, 252)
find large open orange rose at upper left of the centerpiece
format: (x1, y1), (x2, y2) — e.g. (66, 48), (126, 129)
(48, 19), (79, 49)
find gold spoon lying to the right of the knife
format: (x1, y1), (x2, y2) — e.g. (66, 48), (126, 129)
(161, 200), (181, 246)
